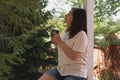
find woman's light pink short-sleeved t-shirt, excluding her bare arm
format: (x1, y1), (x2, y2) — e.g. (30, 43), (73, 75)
(57, 31), (88, 78)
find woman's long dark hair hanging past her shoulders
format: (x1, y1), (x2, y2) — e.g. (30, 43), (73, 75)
(68, 8), (87, 38)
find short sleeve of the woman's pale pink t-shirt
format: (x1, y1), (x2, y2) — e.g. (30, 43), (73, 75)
(73, 31), (87, 52)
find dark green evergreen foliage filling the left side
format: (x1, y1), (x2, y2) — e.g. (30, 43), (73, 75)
(0, 0), (57, 80)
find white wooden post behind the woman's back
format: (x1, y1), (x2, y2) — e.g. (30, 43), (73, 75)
(83, 0), (94, 80)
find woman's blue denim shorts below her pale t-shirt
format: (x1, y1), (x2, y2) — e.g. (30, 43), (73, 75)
(46, 68), (87, 80)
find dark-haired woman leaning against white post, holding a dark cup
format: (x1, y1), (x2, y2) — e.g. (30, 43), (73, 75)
(38, 8), (87, 80)
